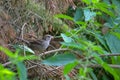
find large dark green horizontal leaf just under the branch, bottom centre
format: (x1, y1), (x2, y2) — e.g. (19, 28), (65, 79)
(42, 53), (76, 66)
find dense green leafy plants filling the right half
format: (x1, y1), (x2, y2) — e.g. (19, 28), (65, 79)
(42, 0), (120, 80)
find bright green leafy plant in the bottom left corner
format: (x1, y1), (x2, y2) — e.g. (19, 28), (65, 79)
(0, 46), (37, 80)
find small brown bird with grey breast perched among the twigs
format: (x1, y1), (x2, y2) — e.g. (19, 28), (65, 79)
(28, 35), (53, 52)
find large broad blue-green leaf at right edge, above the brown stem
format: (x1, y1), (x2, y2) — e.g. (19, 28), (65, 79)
(105, 32), (120, 66)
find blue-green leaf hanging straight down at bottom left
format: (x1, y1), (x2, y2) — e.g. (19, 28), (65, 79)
(16, 62), (27, 80)
